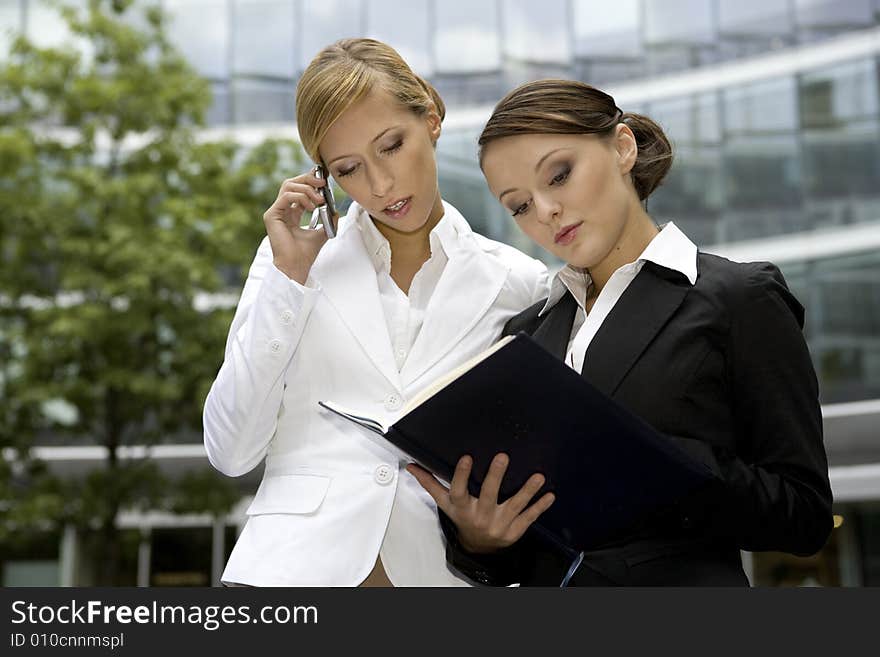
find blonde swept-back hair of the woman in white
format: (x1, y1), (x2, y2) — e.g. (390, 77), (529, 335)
(296, 39), (446, 162)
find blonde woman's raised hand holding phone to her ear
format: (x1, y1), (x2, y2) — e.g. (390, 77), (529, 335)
(263, 171), (336, 285)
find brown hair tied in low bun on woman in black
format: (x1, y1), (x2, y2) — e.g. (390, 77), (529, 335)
(478, 80), (672, 200)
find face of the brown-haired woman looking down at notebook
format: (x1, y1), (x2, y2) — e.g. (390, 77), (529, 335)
(482, 126), (638, 270)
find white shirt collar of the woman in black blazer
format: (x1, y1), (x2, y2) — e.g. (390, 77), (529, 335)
(538, 221), (697, 317)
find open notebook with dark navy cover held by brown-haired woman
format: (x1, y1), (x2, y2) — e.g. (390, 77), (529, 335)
(319, 333), (715, 550)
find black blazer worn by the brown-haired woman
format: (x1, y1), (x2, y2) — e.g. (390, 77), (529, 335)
(441, 253), (832, 586)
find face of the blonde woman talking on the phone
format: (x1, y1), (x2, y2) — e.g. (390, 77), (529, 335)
(319, 89), (443, 233)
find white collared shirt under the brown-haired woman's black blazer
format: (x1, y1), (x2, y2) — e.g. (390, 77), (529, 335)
(538, 222), (697, 372)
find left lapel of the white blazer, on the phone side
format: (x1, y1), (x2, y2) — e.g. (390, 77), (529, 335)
(309, 203), (403, 392)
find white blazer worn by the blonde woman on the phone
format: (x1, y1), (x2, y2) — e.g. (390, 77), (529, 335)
(204, 203), (549, 586)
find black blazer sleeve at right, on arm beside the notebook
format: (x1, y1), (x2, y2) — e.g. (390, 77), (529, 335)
(678, 263), (833, 556)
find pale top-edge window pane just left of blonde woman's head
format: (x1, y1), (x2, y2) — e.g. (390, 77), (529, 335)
(232, 0), (295, 78)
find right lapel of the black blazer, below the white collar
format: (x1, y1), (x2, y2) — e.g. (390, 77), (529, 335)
(583, 262), (691, 396)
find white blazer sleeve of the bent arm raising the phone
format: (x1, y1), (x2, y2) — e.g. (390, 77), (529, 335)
(202, 237), (318, 477)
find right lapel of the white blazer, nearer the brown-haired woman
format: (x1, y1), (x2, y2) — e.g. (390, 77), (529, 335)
(392, 203), (509, 387)
